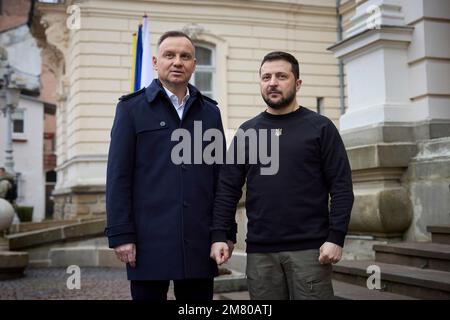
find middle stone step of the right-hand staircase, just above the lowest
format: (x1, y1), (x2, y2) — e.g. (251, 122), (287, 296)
(373, 242), (450, 272)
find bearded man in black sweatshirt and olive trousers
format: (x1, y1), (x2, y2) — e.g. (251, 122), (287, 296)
(211, 52), (353, 300)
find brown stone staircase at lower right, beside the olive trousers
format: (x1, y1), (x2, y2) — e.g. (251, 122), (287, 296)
(333, 225), (450, 299)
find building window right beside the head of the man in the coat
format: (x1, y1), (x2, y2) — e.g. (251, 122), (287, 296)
(191, 45), (216, 99)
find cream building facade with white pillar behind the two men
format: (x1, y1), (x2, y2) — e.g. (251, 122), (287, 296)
(29, 0), (450, 252)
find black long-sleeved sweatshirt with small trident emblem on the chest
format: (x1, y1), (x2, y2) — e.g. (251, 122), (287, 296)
(211, 107), (353, 253)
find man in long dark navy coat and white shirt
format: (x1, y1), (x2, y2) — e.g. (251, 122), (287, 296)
(105, 31), (232, 300)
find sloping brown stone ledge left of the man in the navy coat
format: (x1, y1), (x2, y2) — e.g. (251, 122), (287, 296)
(5, 218), (106, 250)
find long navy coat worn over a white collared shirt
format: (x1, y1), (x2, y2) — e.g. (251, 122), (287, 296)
(105, 79), (225, 280)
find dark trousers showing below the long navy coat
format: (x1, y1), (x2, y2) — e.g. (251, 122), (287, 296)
(130, 278), (214, 301)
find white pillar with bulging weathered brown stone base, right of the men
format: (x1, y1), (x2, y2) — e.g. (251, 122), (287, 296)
(330, 0), (450, 249)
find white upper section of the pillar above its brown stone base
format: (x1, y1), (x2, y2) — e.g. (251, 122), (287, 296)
(331, 0), (417, 130)
